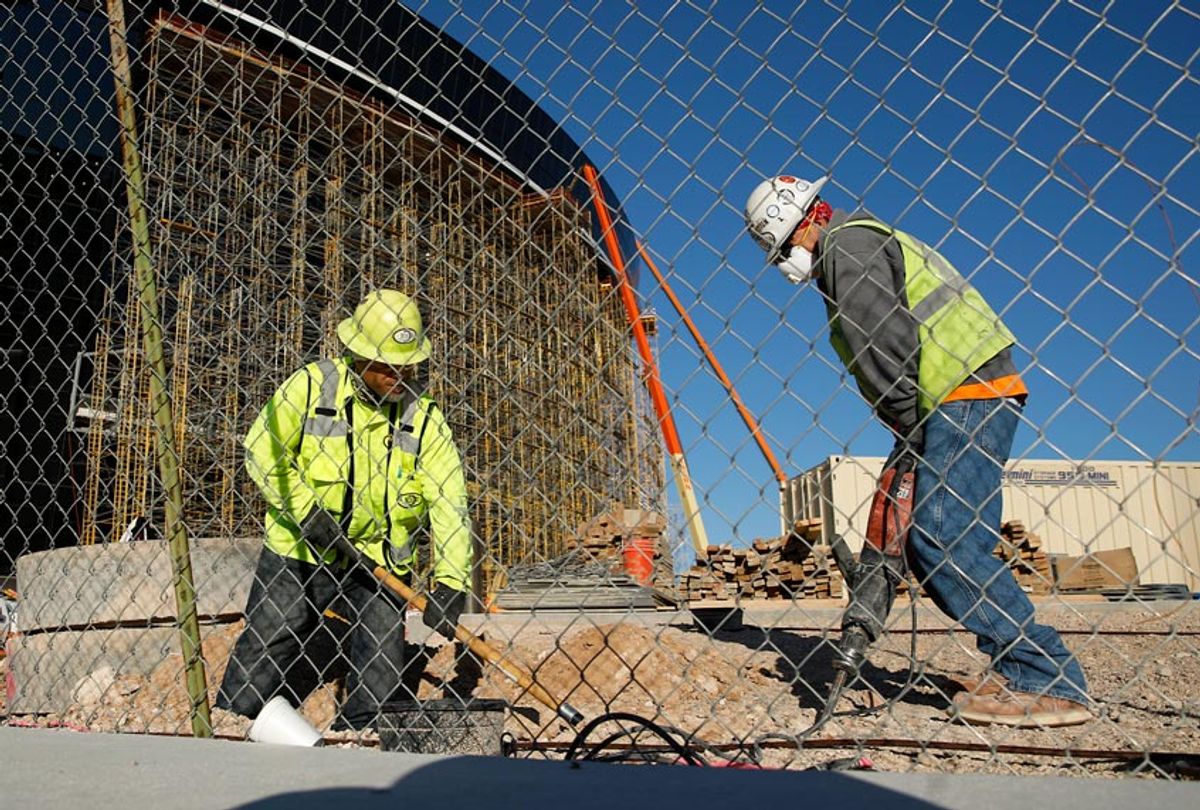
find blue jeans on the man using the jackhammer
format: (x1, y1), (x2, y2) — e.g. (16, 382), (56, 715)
(908, 400), (1087, 703)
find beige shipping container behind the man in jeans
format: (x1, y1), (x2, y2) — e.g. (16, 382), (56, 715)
(784, 456), (1200, 592)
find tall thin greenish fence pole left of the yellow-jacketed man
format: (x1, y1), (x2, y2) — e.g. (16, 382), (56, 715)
(107, 0), (212, 737)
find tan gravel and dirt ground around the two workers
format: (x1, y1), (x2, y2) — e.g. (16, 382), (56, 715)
(0, 602), (1200, 776)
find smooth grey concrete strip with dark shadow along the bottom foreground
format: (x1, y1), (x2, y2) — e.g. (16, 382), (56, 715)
(0, 728), (1200, 810)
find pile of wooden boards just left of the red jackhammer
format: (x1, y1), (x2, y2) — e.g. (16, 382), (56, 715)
(683, 521), (842, 600)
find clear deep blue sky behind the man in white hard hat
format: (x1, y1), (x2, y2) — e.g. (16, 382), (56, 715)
(406, 0), (1200, 541)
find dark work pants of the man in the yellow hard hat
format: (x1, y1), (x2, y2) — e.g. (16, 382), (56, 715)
(216, 548), (404, 730)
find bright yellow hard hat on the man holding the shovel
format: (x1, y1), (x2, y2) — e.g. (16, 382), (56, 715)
(337, 289), (432, 366)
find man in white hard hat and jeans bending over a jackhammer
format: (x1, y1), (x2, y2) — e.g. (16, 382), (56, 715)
(745, 176), (1091, 727)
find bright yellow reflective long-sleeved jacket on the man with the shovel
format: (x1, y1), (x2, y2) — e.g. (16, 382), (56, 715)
(245, 359), (472, 590)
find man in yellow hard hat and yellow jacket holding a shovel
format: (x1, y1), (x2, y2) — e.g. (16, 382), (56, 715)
(216, 289), (472, 730)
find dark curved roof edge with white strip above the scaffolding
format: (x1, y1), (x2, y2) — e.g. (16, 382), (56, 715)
(180, 0), (637, 284)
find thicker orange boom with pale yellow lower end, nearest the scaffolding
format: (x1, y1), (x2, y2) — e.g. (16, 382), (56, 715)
(583, 164), (708, 557)
